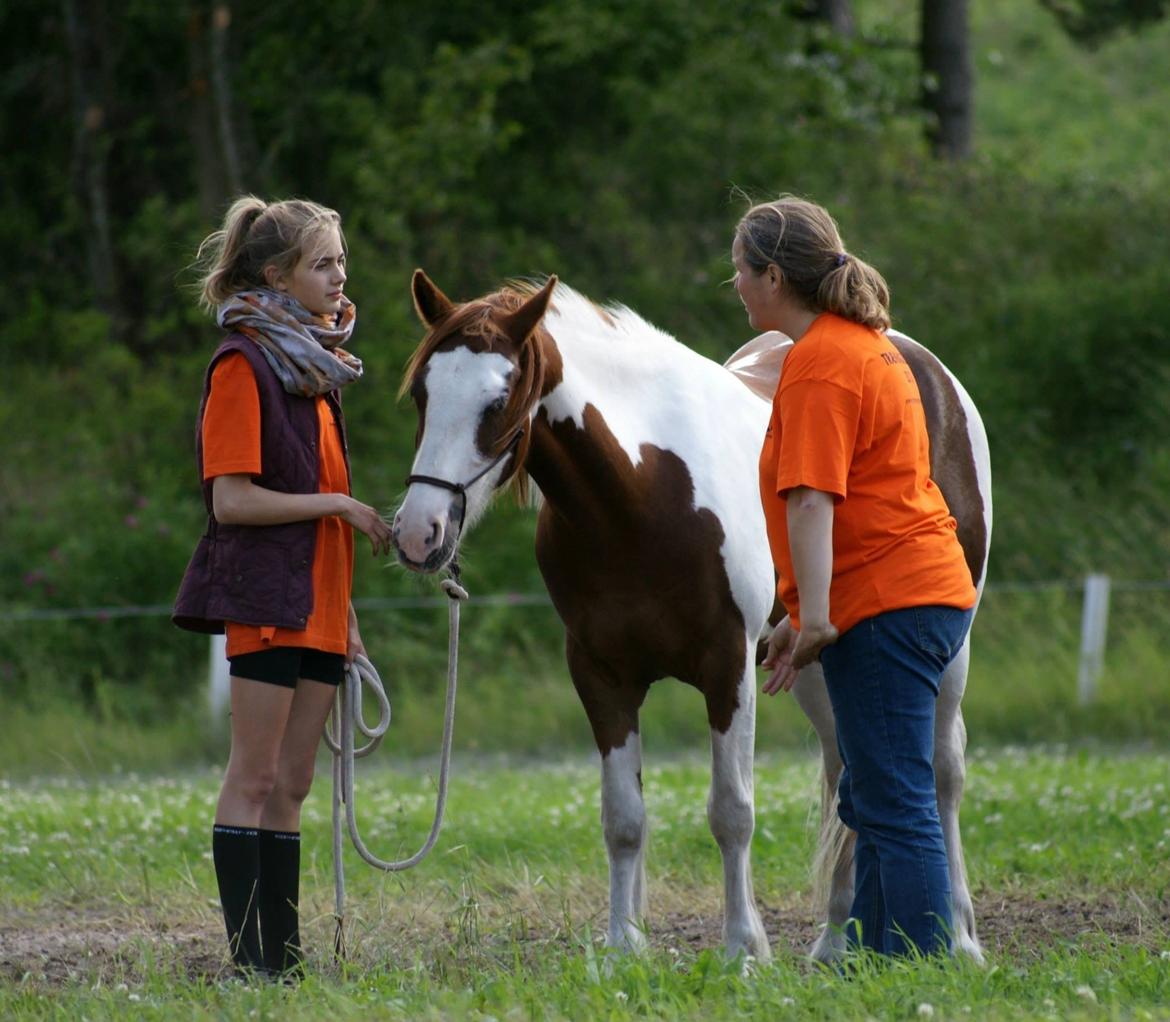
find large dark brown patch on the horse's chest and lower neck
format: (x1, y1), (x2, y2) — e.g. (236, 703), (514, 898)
(528, 405), (745, 755)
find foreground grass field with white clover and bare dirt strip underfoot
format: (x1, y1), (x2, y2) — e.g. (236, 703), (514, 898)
(0, 745), (1170, 1020)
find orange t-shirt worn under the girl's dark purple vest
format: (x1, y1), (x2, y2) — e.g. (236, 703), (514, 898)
(202, 352), (353, 656)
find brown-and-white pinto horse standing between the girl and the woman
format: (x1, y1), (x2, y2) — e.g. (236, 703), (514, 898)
(393, 270), (990, 961)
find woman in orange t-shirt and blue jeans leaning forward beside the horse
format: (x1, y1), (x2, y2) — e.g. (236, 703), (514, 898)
(731, 195), (976, 954)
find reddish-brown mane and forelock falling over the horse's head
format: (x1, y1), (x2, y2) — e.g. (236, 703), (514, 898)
(398, 281), (550, 504)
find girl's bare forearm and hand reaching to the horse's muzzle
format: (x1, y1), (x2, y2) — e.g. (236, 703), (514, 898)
(212, 475), (390, 554)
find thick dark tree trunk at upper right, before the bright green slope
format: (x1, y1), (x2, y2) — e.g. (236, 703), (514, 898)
(921, 0), (975, 159)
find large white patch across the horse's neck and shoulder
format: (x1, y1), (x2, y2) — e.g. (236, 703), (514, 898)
(542, 284), (772, 635)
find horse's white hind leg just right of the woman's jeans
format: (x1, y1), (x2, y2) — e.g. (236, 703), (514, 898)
(935, 635), (983, 962)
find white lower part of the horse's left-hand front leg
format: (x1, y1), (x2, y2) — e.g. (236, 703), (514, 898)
(601, 732), (646, 951)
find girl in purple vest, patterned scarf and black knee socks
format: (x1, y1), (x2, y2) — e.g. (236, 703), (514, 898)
(173, 195), (390, 974)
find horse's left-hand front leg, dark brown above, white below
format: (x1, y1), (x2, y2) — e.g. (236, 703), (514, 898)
(566, 637), (648, 951)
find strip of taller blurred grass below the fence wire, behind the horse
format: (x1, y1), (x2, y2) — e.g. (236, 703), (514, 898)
(9, 572), (1170, 778)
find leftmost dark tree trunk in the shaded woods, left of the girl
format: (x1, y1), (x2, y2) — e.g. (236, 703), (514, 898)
(61, 0), (122, 315)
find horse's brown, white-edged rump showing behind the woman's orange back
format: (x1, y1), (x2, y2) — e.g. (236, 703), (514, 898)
(889, 336), (987, 585)
